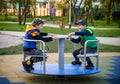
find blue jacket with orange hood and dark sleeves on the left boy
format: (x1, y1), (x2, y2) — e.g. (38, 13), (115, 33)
(23, 26), (52, 50)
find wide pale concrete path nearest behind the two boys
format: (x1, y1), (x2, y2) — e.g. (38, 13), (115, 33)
(0, 31), (120, 48)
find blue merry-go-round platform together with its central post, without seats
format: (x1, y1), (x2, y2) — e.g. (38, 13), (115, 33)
(22, 35), (101, 76)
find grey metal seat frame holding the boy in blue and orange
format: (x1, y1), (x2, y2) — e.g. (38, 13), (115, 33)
(23, 39), (47, 73)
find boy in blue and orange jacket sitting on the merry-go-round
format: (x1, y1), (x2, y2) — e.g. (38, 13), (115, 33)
(22, 18), (54, 72)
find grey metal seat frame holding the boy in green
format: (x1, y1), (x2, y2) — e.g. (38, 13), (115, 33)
(77, 40), (99, 73)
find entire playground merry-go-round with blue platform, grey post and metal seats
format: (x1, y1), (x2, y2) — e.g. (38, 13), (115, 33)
(22, 35), (101, 76)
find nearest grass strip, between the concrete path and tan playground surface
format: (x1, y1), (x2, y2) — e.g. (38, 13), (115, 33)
(0, 40), (120, 55)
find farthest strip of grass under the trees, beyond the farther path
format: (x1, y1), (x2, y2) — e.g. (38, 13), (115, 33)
(0, 15), (119, 28)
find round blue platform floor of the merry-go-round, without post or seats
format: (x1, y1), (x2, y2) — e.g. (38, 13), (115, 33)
(22, 64), (101, 76)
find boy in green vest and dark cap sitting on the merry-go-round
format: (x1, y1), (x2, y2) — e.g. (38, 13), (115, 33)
(68, 20), (97, 69)
